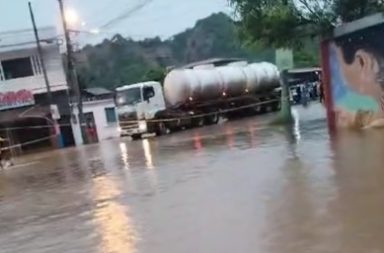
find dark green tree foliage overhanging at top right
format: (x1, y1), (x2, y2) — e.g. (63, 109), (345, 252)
(229, 0), (384, 47)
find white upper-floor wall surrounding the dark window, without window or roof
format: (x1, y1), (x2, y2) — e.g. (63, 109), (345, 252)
(0, 44), (68, 94)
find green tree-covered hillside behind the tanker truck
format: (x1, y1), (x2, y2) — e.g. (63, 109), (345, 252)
(78, 13), (318, 89)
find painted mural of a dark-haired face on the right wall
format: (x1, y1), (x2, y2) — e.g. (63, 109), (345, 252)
(328, 21), (384, 128)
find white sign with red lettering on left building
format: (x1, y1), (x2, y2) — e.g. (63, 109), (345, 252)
(0, 90), (35, 110)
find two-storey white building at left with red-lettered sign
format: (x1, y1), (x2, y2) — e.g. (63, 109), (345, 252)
(0, 27), (74, 149)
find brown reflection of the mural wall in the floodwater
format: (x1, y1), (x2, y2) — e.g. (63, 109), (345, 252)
(329, 131), (384, 252)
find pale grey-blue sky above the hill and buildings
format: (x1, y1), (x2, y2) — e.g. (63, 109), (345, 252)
(0, 0), (231, 43)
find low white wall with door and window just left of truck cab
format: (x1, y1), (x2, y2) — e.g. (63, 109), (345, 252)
(72, 99), (120, 145)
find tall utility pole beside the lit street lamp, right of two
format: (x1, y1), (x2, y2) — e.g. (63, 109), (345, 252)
(58, 0), (87, 144)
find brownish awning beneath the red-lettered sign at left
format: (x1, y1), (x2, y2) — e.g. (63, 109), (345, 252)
(0, 105), (50, 124)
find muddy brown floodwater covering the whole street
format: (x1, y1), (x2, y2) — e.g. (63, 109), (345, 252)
(0, 106), (384, 253)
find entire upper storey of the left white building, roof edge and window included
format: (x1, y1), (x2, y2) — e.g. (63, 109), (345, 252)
(0, 27), (68, 95)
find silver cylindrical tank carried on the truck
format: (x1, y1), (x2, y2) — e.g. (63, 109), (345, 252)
(164, 62), (280, 106)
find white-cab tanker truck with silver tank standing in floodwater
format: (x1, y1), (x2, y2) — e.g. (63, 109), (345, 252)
(115, 62), (281, 139)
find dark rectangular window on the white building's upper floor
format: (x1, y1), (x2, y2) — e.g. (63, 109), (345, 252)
(1, 57), (33, 80)
